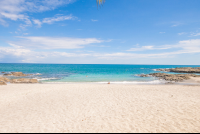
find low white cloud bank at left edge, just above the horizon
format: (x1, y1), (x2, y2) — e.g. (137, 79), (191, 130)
(0, 45), (90, 63)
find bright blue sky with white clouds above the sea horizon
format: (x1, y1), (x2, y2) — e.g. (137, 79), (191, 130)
(0, 0), (200, 65)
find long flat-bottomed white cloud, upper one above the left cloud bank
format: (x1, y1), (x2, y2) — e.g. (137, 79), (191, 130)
(9, 36), (105, 49)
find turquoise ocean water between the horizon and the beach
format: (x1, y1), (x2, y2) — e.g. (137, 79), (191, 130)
(0, 63), (200, 83)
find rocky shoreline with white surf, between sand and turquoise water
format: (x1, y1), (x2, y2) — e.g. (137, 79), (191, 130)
(0, 67), (200, 85)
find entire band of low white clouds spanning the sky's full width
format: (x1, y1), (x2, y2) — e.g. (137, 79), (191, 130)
(0, 37), (200, 63)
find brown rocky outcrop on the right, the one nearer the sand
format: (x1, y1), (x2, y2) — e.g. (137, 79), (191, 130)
(149, 73), (200, 82)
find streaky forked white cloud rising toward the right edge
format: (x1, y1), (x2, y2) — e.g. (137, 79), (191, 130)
(108, 39), (200, 59)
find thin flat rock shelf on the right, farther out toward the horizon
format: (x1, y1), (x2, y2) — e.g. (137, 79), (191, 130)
(156, 67), (200, 73)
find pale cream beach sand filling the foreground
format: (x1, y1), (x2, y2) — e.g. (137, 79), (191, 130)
(0, 84), (200, 133)
